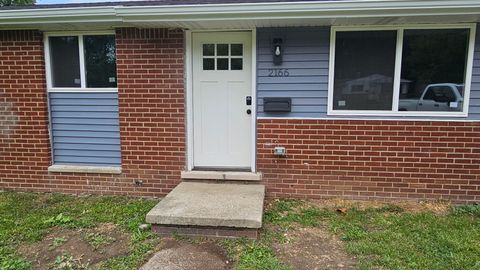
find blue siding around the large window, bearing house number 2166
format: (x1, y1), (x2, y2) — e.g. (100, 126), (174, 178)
(257, 25), (480, 120)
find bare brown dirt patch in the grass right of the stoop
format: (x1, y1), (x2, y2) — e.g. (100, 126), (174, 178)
(273, 228), (356, 270)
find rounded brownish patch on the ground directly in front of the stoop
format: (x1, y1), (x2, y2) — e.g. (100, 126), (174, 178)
(140, 238), (231, 270)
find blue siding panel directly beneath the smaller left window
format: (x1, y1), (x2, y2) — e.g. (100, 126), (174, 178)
(50, 92), (121, 166)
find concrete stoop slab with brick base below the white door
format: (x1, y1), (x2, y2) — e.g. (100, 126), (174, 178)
(146, 182), (265, 238)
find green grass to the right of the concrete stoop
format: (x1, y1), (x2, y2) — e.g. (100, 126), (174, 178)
(265, 200), (480, 270)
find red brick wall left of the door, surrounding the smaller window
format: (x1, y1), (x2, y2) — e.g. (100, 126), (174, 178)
(0, 28), (185, 196)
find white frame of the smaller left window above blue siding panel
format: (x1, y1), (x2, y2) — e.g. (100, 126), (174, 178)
(43, 31), (118, 93)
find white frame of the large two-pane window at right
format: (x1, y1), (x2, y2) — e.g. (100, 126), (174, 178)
(327, 23), (477, 117)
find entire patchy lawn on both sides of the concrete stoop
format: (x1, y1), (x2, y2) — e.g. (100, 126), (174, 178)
(0, 192), (480, 270)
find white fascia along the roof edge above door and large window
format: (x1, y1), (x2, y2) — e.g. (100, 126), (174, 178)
(116, 0), (480, 20)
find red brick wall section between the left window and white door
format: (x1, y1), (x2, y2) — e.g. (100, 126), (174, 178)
(117, 28), (185, 195)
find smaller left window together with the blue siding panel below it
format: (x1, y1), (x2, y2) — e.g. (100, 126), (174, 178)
(45, 32), (121, 167)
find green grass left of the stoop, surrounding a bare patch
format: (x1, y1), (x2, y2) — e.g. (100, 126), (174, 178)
(0, 192), (158, 270)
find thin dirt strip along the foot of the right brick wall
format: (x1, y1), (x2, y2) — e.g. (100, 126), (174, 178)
(308, 198), (451, 215)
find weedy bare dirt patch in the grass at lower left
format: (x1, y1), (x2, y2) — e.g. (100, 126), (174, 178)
(18, 223), (130, 269)
